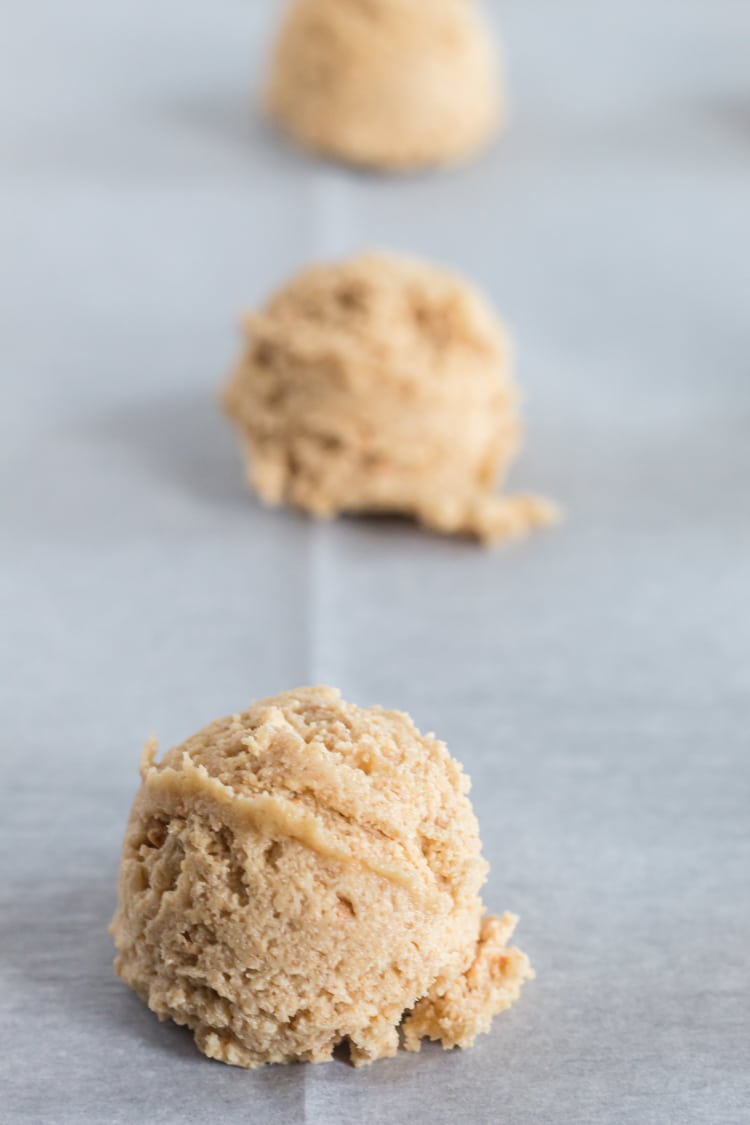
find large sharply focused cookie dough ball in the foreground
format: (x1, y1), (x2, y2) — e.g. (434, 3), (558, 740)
(111, 687), (531, 1068)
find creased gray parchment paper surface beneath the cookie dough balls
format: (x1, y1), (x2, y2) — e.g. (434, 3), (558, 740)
(0, 0), (750, 1125)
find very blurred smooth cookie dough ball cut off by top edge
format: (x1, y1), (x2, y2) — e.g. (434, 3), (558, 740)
(266, 0), (504, 171)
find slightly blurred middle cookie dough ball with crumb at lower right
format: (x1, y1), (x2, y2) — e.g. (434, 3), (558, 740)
(224, 254), (555, 541)
